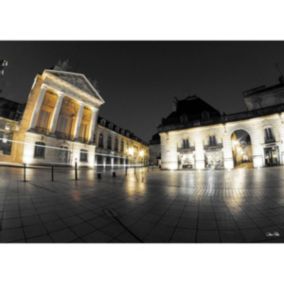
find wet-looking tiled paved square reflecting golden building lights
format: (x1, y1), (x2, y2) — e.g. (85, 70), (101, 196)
(0, 167), (284, 243)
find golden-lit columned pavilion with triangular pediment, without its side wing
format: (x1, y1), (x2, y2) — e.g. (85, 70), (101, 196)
(13, 70), (104, 164)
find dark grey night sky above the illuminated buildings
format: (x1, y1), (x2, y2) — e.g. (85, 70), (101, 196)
(0, 41), (284, 140)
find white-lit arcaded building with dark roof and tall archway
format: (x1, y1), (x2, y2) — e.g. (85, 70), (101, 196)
(158, 78), (284, 169)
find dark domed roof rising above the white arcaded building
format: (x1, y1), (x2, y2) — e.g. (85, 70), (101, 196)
(161, 96), (221, 126)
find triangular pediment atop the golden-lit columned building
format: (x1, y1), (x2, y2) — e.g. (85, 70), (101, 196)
(44, 69), (104, 102)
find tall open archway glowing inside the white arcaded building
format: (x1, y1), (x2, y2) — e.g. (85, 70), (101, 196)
(231, 130), (253, 168)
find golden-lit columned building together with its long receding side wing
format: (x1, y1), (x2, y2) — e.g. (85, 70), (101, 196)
(0, 69), (148, 167)
